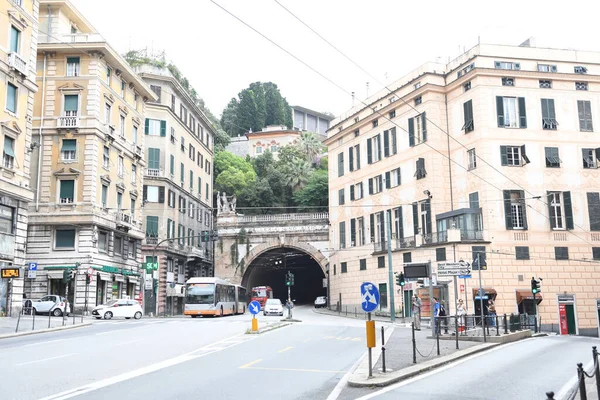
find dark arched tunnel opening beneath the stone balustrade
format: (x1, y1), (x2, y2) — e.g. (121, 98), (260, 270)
(242, 247), (327, 305)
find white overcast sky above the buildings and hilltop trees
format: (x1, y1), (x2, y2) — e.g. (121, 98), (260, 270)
(72, 0), (600, 117)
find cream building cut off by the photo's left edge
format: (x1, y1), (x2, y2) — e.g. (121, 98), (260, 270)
(0, 0), (39, 316)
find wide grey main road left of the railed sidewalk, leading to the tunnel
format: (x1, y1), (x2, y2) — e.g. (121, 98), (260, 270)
(0, 307), (365, 400)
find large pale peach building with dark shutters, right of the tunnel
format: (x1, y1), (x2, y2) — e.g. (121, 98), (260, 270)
(326, 44), (600, 335)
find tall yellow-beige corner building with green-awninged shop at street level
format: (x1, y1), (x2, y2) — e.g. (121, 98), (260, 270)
(25, 0), (156, 312)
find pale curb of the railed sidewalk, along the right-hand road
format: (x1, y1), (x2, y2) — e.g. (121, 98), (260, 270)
(348, 343), (499, 387)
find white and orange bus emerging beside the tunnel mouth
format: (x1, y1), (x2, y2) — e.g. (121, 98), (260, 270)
(183, 278), (241, 318)
